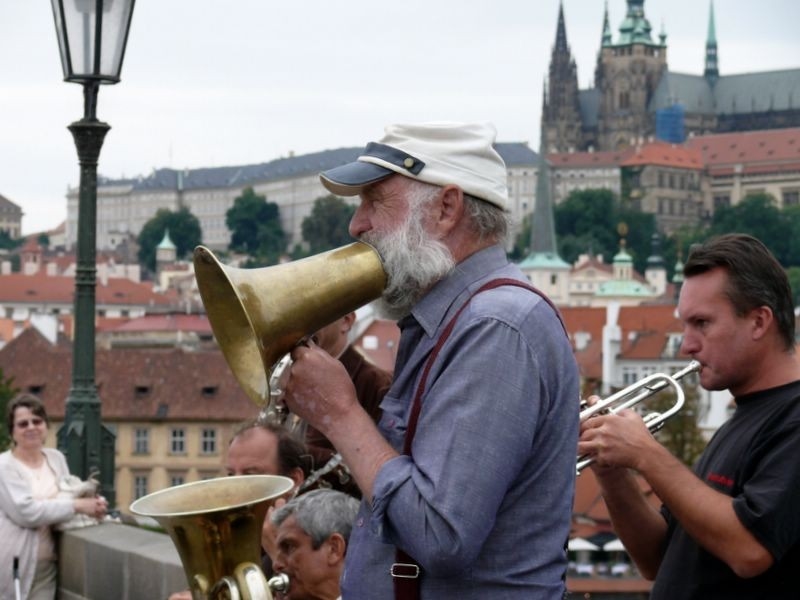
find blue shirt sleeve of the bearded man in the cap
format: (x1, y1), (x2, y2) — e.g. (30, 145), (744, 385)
(369, 315), (563, 575)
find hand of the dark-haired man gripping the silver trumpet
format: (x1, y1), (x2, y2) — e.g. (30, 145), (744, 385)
(578, 409), (657, 470)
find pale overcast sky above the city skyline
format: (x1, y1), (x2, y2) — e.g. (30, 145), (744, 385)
(0, 0), (800, 234)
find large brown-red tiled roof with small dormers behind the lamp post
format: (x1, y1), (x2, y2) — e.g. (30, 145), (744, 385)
(0, 328), (258, 422)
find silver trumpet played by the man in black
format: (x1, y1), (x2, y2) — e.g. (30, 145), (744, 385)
(576, 360), (702, 475)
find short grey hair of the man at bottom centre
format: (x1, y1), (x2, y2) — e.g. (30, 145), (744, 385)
(272, 489), (359, 550)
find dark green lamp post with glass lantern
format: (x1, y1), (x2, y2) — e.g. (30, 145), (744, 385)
(51, 0), (135, 507)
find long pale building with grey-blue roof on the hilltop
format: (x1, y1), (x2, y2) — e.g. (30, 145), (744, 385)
(73, 142), (537, 251)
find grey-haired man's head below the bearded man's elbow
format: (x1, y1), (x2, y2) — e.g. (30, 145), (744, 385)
(271, 490), (358, 600)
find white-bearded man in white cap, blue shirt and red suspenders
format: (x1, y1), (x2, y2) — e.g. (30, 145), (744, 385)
(286, 123), (579, 600)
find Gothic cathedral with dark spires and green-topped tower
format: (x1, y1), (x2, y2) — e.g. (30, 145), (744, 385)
(541, 0), (800, 154)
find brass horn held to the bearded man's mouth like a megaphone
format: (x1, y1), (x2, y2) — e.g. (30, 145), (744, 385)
(194, 242), (386, 412)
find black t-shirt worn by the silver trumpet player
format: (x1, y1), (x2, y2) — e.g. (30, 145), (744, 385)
(650, 381), (800, 600)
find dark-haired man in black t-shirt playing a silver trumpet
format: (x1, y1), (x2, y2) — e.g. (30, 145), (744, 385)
(578, 234), (800, 600)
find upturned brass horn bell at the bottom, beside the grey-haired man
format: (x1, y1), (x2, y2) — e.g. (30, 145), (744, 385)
(130, 475), (294, 600)
